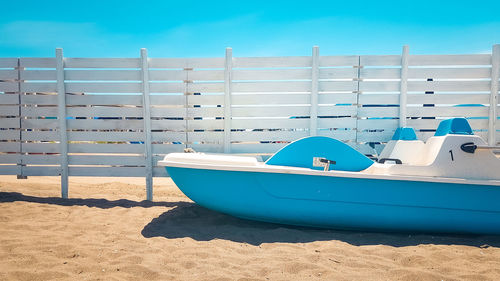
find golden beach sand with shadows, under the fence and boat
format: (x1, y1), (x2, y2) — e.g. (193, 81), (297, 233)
(0, 176), (500, 280)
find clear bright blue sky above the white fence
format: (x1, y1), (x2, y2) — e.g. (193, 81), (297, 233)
(0, 0), (500, 57)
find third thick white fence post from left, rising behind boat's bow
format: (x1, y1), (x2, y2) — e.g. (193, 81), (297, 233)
(224, 48), (233, 153)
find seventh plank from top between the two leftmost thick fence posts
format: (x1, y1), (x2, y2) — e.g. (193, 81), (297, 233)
(68, 131), (145, 142)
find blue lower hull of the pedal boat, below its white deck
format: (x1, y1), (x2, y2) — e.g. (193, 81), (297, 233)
(166, 167), (500, 234)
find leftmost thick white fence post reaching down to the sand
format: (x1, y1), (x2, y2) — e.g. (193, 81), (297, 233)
(56, 48), (69, 198)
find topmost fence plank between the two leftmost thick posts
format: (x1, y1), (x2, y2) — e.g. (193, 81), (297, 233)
(65, 58), (140, 68)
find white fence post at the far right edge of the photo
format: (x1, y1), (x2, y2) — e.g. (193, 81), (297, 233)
(488, 44), (500, 146)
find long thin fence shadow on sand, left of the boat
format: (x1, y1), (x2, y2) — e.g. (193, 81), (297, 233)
(0, 192), (178, 209)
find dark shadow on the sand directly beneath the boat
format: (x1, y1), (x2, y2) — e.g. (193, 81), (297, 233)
(142, 202), (500, 248)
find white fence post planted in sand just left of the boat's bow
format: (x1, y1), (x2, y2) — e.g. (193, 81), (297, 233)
(141, 48), (153, 201)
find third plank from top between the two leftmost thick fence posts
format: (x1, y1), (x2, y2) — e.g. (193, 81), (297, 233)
(66, 82), (141, 93)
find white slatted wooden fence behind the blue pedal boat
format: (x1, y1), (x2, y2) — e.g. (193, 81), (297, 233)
(0, 45), (500, 200)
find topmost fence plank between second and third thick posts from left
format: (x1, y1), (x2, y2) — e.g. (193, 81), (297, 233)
(149, 58), (224, 68)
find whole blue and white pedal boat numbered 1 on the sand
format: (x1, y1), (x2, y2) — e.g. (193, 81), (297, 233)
(158, 118), (500, 234)
